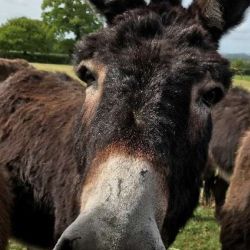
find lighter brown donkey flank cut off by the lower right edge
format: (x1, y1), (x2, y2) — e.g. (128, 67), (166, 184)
(220, 131), (250, 250)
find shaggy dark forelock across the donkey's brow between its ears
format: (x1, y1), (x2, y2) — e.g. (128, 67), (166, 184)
(74, 3), (219, 65)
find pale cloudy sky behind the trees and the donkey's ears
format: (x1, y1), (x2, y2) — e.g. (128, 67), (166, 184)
(0, 0), (250, 54)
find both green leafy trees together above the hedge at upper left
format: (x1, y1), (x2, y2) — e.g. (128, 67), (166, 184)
(0, 0), (103, 62)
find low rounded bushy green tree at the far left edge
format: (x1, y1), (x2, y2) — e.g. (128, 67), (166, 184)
(0, 17), (55, 53)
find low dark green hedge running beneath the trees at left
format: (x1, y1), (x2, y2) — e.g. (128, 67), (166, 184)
(0, 51), (71, 64)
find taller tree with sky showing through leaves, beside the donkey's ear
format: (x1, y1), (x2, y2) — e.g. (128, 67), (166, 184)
(42, 0), (102, 40)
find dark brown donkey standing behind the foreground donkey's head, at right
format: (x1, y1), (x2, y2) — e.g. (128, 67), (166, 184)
(205, 87), (250, 219)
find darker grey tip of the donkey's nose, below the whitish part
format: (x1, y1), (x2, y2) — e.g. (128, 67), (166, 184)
(54, 210), (165, 250)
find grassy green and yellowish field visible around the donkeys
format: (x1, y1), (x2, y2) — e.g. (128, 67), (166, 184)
(6, 63), (250, 250)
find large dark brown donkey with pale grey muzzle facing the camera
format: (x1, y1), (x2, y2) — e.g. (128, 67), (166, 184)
(0, 0), (250, 250)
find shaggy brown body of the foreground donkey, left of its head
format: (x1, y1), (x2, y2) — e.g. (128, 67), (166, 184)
(0, 69), (84, 247)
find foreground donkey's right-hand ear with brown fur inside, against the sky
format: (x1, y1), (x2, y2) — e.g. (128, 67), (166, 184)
(190, 0), (250, 41)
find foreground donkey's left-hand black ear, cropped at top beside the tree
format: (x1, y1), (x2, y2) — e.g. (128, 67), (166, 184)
(89, 0), (146, 24)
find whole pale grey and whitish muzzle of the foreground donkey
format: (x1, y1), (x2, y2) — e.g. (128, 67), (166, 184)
(54, 155), (168, 250)
